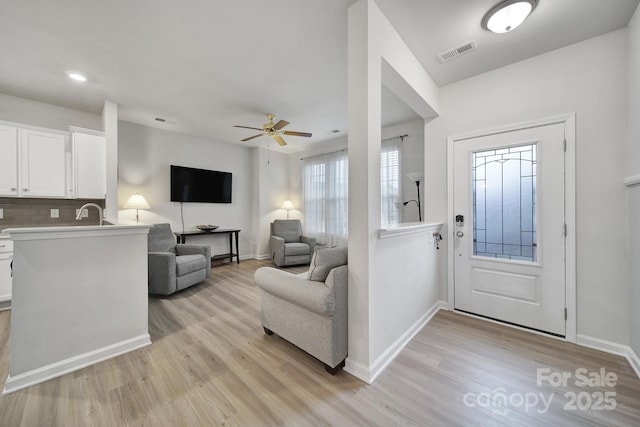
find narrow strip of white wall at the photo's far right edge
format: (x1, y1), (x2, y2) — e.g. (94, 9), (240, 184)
(627, 6), (640, 355)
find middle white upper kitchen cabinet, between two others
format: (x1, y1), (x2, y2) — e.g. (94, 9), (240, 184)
(18, 129), (67, 198)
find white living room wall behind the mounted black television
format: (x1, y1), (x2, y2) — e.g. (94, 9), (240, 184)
(118, 121), (255, 258)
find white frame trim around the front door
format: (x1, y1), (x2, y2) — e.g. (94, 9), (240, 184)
(446, 113), (577, 343)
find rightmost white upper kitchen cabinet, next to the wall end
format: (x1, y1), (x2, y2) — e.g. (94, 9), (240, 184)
(71, 128), (107, 199)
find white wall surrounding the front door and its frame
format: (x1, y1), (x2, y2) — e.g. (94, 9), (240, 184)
(425, 29), (629, 344)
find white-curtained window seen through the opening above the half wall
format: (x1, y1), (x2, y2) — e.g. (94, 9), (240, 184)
(380, 139), (402, 226)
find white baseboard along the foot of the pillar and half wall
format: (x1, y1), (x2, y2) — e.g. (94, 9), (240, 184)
(344, 301), (448, 384)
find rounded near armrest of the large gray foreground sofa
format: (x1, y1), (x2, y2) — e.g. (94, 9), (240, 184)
(254, 267), (335, 316)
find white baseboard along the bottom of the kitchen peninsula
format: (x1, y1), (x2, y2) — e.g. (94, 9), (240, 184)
(2, 334), (151, 395)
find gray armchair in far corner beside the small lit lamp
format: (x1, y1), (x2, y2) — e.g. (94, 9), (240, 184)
(269, 219), (316, 267)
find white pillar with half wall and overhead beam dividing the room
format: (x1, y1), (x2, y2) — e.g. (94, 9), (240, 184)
(346, 0), (439, 381)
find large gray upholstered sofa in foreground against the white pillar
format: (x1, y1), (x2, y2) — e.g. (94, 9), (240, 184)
(254, 246), (348, 374)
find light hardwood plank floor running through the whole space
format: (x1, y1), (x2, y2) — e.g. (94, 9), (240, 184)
(0, 261), (640, 427)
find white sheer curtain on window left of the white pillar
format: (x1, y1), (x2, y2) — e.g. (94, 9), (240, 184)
(302, 151), (349, 245)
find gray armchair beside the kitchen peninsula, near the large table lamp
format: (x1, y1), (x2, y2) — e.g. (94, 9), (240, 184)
(149, 224), (211, 295)
